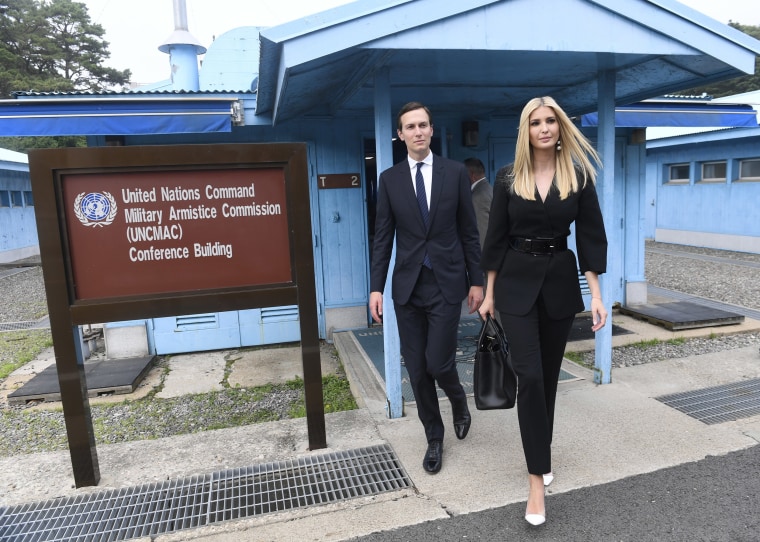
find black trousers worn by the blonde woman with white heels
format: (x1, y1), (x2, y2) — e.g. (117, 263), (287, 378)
(500, 296), (575, 474)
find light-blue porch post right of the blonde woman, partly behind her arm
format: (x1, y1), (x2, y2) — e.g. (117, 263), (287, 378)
(594, 70), (621, 384)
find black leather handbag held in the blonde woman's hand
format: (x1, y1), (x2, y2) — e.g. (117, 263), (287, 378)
(473, 314), (517, 410)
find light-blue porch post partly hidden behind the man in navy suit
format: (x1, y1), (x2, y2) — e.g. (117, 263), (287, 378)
(375, 68), (404, 418)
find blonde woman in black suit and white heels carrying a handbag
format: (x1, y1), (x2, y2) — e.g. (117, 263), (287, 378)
(479, 97), (607, 525)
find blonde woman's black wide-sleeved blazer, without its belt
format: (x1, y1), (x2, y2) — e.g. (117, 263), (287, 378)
(482, 166), (607, 319)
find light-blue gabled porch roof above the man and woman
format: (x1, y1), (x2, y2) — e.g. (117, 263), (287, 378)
(256, 0), (760, 122)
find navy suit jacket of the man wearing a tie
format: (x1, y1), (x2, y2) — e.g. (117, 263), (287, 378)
(370, 155), (483, 305)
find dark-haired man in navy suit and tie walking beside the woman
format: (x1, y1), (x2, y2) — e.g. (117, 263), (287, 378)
(369, 102), (483, 474)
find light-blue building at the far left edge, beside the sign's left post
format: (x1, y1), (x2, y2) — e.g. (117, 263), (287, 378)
(0, 149), (35, 263)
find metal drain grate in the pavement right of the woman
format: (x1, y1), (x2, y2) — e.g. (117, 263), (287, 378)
(655, 379), (760, 425)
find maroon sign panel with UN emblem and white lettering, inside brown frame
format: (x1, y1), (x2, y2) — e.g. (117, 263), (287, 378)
(63, 168), (292, 299)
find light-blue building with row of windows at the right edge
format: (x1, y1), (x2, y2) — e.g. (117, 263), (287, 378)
(646, 90), (760, 253)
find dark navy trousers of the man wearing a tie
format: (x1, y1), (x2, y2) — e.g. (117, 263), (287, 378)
(394, 267), (467, 442)
